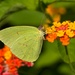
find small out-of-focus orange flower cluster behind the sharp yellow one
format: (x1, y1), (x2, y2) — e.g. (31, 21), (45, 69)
(46, 4), (66, 22)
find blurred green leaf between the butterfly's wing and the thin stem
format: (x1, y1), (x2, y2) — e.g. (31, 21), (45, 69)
(35, 41), (60, 68)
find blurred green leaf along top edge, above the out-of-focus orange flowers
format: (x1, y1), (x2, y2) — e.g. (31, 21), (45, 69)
(43, 0), (75, 7)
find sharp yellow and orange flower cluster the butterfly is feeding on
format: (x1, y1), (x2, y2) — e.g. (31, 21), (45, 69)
(45, 21), (75, 46)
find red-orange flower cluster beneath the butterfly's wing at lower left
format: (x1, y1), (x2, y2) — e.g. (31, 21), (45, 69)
(0, 46), (33, 75)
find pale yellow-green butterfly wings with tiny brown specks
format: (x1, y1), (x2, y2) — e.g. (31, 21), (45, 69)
(0, 26), (43, 62)
